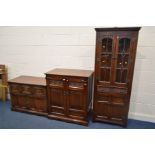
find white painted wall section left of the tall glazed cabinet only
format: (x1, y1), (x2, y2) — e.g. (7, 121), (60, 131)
(0, 27), (95, 78)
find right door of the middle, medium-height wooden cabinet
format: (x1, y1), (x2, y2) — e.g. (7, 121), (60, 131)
(67, 82), (88, 117)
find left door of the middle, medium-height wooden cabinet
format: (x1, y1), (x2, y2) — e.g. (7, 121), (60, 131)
(49, 80), (66, 115)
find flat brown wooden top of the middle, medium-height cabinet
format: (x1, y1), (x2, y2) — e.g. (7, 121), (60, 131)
(45, 69), (93, 77)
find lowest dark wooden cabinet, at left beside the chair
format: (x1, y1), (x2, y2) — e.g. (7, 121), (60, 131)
(9, 76), (47, 116)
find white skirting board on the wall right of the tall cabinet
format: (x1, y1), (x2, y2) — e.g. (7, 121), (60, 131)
(129, 112), (155, 123)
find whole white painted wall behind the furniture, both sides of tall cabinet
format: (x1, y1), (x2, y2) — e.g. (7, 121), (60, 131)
(0, 27), (155, 122)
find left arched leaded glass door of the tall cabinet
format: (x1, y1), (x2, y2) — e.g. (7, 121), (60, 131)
(95, 35), (115, 85)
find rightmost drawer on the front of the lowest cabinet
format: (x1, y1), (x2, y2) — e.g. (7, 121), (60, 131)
(33, 87), (46, 98)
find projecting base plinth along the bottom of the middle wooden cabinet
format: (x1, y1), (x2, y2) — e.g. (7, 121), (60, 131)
(48, 114), (88, 126)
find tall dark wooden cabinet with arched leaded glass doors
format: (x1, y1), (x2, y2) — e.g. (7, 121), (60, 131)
(93, 27), (140, 126)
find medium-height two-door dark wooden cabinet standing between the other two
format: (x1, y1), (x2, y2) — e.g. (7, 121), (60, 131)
(46, 69), (93, 125)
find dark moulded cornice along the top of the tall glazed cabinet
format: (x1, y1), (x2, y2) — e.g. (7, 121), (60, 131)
(95, 27), (141, 32)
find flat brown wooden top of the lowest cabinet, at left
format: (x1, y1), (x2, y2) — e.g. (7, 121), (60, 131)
(9, 76), (46, 86)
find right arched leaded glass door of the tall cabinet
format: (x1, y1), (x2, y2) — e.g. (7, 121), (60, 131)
(113, 35), (133, 87)
